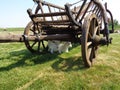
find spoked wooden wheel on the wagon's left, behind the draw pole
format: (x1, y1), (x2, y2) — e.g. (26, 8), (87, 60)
(24, 21), (47, 53)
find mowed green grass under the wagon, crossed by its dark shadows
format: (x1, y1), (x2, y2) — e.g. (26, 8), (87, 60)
(0, 28), (120, 90)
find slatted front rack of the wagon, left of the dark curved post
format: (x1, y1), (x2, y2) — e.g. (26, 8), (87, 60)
(27, 0), (70, 25)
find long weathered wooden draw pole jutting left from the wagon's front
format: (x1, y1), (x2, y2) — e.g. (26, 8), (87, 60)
(0, 34), (72, 43)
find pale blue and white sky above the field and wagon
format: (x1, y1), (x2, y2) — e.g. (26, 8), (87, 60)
(0, 0), (120, 28)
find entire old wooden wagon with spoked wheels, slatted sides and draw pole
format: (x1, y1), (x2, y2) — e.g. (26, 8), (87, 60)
(0, 0), (114, 67)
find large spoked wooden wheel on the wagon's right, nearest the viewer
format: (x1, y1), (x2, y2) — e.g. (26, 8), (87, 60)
(81, 14), (100, 67)
